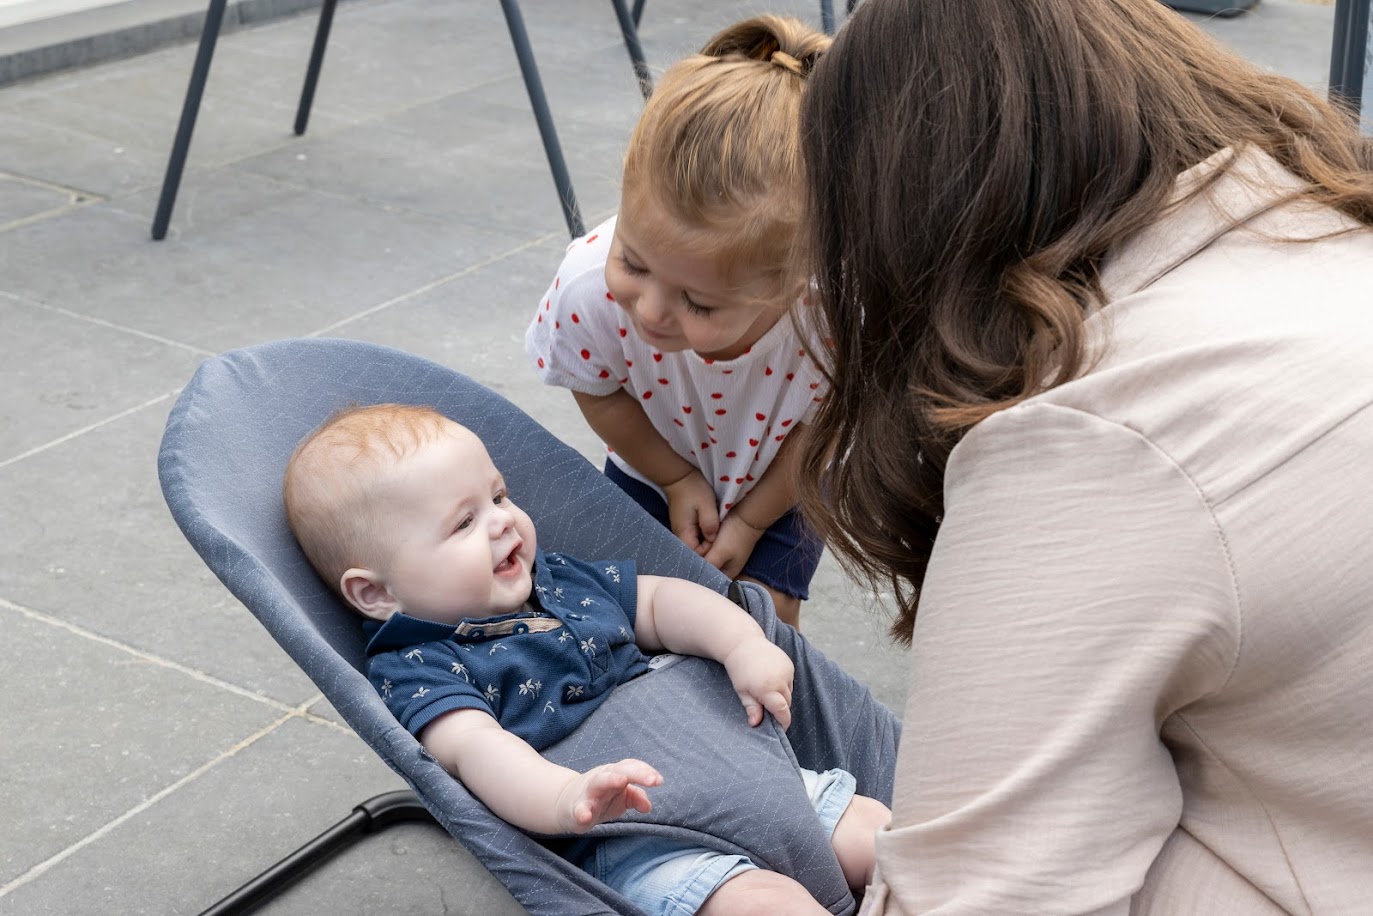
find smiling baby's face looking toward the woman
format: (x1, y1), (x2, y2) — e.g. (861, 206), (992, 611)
(376, 424), (535, 623)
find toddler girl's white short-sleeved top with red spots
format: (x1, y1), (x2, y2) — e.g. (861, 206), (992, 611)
(524, 217), (827, 516)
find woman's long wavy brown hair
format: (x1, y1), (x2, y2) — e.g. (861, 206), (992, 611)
(800, 0), (1373, 641)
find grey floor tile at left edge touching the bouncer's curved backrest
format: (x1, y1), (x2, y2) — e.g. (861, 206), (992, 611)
(0, 398), (314, 706)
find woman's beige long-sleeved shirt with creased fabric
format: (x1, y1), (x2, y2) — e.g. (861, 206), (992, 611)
(865, 146), (1373, 916)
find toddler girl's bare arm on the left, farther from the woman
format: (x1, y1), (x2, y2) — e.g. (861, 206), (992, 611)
(573, 390), (719, 555)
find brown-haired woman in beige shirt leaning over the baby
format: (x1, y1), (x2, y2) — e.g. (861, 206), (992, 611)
(803, 0), (1373, 913)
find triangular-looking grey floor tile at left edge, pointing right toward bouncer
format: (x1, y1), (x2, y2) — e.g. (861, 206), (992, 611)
(0, 601), (281, 878)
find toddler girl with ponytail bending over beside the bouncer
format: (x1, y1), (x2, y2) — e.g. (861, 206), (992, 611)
(524, 16), (829, 625)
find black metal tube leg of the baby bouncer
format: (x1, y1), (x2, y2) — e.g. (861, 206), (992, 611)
(200, 788), (437, 916)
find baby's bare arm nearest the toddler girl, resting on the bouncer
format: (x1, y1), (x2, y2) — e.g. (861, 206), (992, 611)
(634, 575), (795, 728)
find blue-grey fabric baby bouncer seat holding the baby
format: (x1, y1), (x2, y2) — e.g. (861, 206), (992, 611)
(158, 339), (901, 916)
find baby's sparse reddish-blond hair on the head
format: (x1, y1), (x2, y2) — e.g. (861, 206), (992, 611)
(281, 404), (450, 592)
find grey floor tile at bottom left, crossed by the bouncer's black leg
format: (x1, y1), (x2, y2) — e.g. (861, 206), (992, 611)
(0, 720), (519, 916)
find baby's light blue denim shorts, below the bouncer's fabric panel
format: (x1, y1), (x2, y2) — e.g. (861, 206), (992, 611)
(581, 769), (855, 916)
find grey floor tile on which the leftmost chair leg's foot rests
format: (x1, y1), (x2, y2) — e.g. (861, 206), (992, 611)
(4, 194), (524, 352)
